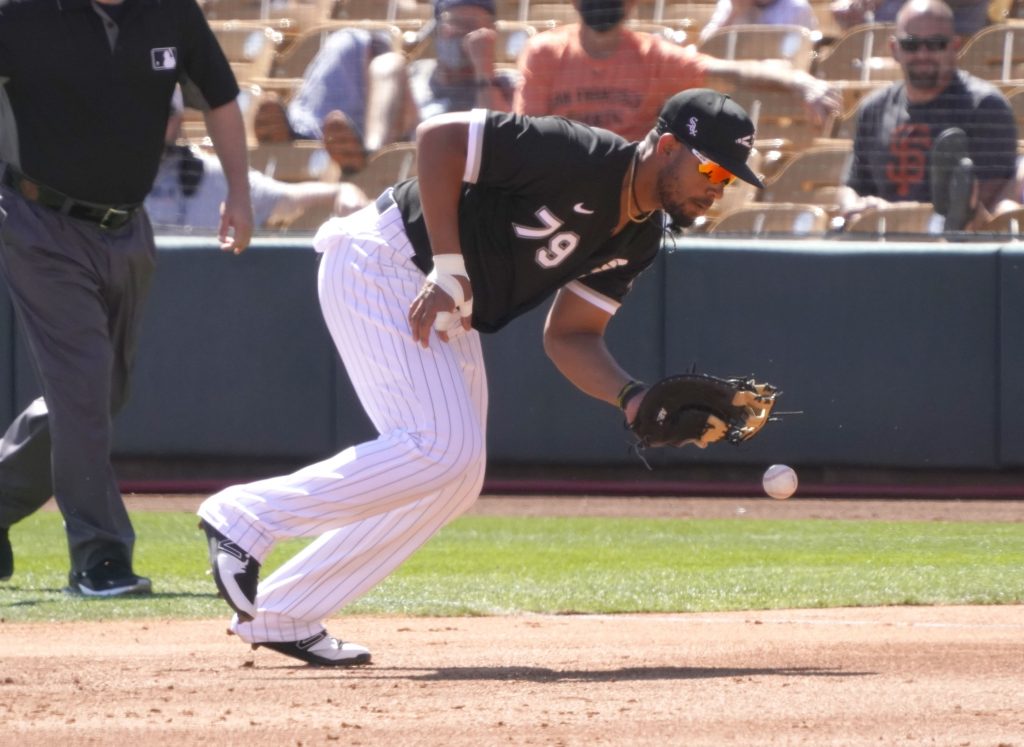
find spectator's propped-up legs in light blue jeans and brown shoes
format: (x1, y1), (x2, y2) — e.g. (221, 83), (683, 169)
(253, 29), (391, 175)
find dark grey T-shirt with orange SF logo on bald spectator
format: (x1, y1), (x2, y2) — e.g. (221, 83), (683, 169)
(846, 71), (1017, 202)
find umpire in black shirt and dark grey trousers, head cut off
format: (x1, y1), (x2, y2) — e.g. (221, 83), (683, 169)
(0, 0), (252, 596)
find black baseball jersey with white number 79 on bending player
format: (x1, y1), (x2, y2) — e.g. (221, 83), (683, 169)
(394, 110), (662, 332)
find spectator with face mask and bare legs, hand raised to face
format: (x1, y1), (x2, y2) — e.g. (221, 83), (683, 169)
(367, 0), (518, 150)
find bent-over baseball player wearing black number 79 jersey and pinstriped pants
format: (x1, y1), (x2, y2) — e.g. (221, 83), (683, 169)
(199, 89), (762, 666)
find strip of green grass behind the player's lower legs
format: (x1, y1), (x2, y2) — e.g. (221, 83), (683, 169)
(0, 512), (1024, 622)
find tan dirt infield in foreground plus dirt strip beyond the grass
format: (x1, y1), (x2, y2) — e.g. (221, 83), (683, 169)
(0, 498), (1024, 747)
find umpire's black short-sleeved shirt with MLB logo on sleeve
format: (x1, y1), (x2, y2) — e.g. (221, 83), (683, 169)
(0, 0), (239, 205)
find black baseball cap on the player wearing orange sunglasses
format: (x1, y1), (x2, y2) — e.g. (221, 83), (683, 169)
(655, 88), (764, 190)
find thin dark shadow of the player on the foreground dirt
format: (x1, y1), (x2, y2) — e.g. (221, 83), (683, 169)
(372, 666), (873, 683)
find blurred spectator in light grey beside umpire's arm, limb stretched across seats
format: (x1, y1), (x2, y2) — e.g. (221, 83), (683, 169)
(153, 92), (369, 231)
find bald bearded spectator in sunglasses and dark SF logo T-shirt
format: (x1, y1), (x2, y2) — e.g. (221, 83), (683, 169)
(841, 0), (1017, 230)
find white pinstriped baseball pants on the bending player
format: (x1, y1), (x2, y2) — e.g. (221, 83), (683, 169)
(199, 196), (487, 642)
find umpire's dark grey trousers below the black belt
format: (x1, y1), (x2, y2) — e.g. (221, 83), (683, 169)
(0, 183), (156, 573)
